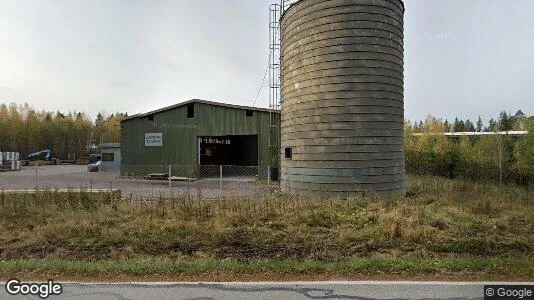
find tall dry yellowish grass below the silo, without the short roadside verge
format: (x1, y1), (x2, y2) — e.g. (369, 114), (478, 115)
(0, 177), (534, 261)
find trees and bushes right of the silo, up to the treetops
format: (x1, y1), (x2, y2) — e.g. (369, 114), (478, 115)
(405, 111), (534, 185)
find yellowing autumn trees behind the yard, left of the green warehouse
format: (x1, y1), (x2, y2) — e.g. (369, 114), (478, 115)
(0, 103), (127, 160)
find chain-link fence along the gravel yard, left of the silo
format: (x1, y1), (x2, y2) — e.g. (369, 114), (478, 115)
(4, 165), (279, 201)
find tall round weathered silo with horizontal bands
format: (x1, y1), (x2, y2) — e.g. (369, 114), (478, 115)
(281, 0), (406, 196)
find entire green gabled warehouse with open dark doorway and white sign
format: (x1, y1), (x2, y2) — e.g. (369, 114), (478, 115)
(121, 99), (280, 175)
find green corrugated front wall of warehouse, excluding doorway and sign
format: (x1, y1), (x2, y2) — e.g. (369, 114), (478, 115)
(121, 102), (269, 170)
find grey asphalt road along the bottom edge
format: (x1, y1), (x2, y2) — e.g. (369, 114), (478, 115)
(0, 282), (532, 300)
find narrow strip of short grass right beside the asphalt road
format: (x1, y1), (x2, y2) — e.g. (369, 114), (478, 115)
(0, 257), (534, 280)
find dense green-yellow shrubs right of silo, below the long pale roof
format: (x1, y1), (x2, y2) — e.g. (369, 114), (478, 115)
(405, 135), (534, 185)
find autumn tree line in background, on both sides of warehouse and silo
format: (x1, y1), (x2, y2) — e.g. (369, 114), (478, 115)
(0, 103), (534, 184)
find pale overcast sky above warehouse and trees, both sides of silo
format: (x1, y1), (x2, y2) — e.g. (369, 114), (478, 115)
(0, 0), (534, 121)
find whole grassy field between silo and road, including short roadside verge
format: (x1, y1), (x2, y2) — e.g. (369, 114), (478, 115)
(0, 177), (534, 279)
